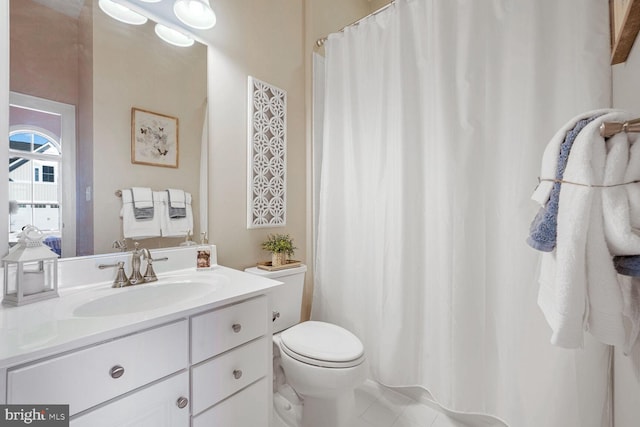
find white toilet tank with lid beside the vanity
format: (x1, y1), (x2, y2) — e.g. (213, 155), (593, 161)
(244, 264), (307, 334)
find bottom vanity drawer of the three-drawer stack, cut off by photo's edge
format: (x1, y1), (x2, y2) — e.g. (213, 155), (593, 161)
(192, 378), (269, 427)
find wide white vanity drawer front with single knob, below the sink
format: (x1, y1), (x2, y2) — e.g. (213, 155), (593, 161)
(7, 320), (189, 415)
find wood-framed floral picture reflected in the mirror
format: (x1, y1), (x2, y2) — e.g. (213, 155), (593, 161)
(131, 108), (178, 168)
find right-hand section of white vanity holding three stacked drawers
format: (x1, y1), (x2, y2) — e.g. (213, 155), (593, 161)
(191, 296), (271, 427)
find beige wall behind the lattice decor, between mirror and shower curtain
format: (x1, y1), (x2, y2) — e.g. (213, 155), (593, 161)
(208, 0), (308, 269)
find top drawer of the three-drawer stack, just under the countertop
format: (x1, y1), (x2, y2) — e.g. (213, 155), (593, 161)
(191, 296), (269, 364)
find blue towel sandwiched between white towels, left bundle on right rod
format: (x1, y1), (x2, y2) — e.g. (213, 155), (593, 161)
(527, 116), (598, 252)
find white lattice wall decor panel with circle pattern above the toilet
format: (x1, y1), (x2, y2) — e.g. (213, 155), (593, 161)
(247, 76), (287, 228)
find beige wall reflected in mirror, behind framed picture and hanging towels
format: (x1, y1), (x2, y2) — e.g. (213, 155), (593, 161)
(91, 8), (207, 253)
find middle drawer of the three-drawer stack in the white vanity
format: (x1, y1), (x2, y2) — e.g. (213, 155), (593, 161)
(191, 337), (269, 414)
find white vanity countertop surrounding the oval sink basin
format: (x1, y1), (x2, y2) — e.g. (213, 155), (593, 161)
(0, 264), (281, 369)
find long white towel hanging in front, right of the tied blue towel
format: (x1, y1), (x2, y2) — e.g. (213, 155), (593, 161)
(538, 113), (625, 348)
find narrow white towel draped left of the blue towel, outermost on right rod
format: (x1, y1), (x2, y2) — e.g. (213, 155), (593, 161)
(531, 108), (614, 206)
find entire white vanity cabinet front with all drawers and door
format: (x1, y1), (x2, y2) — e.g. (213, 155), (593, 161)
(0, 295), (272, 427)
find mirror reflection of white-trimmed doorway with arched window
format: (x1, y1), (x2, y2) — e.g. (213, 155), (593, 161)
(9, 92), (76, 256)
